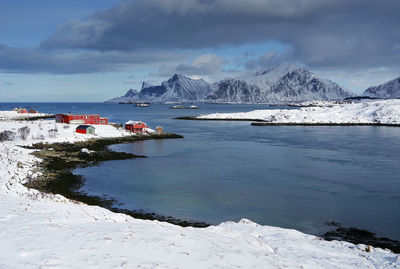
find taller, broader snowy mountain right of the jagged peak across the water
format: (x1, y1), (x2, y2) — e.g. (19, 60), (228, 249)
(207, 63), (353, 103)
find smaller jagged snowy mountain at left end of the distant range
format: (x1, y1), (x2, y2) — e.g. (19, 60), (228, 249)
(108, 74), (214, 103)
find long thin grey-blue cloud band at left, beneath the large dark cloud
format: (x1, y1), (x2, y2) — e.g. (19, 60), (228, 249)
(0, 45), (188, 74)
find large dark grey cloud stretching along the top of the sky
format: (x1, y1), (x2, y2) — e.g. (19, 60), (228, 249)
(42, 0), (400, 67)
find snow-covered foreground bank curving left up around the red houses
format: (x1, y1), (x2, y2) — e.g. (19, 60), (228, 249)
(0, 113), (400, 269)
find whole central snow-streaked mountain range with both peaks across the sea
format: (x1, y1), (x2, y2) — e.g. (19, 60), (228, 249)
(108, 63), (354, 103)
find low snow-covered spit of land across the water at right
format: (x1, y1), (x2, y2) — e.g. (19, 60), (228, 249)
(197, 99), (400, 124)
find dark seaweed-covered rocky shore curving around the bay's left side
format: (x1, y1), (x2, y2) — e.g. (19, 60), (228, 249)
(24, 133), (210, 228)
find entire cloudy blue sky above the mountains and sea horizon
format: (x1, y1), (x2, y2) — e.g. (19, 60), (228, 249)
(0, 0), (400, 102)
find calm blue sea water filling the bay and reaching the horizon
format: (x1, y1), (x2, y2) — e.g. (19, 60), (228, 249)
(0, 103), (400, 239)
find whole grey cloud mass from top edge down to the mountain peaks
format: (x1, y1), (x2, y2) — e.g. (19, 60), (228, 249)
(0, 0), (400, 77)
